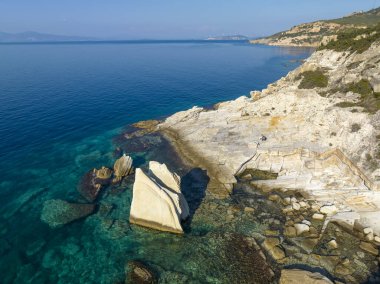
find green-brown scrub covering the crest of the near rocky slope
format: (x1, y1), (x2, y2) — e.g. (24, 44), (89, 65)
(319, 23), (380, 53)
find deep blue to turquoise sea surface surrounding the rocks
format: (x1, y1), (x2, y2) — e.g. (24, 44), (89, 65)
(0, 41), (311, 283)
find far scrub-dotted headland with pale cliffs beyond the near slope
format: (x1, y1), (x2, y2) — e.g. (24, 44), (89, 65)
(250, 8), (380, 47)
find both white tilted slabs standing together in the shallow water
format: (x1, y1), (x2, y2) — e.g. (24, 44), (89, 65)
(129, 163), (188, 234)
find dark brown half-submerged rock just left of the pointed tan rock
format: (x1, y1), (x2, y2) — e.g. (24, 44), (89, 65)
(78, 168), (112, 202)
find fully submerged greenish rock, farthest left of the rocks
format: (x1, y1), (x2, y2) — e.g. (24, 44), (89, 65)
(41, 199), (95, 228)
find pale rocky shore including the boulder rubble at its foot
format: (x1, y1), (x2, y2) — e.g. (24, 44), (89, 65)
(143, 41), (380, 283)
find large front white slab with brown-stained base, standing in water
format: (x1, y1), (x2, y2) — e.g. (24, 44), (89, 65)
(129, 168), (183, 234)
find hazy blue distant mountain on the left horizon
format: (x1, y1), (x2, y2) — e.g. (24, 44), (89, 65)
(0, 32), (94, 43)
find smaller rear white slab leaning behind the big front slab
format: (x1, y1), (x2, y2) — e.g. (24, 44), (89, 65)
(149, 161), (190, 220)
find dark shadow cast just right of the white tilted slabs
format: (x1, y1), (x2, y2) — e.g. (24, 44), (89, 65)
(181, 168), (210, 231)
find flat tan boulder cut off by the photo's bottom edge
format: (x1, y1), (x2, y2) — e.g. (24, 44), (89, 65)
(279, 269), (333, 284)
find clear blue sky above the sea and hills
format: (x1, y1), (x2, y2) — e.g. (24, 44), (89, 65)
(0, 0), (380, 39)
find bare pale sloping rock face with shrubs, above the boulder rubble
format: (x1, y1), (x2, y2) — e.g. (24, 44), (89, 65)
(159, 43), (380, 235)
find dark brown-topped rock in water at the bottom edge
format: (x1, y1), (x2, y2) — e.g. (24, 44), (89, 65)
(125, 260), (158, 284)
